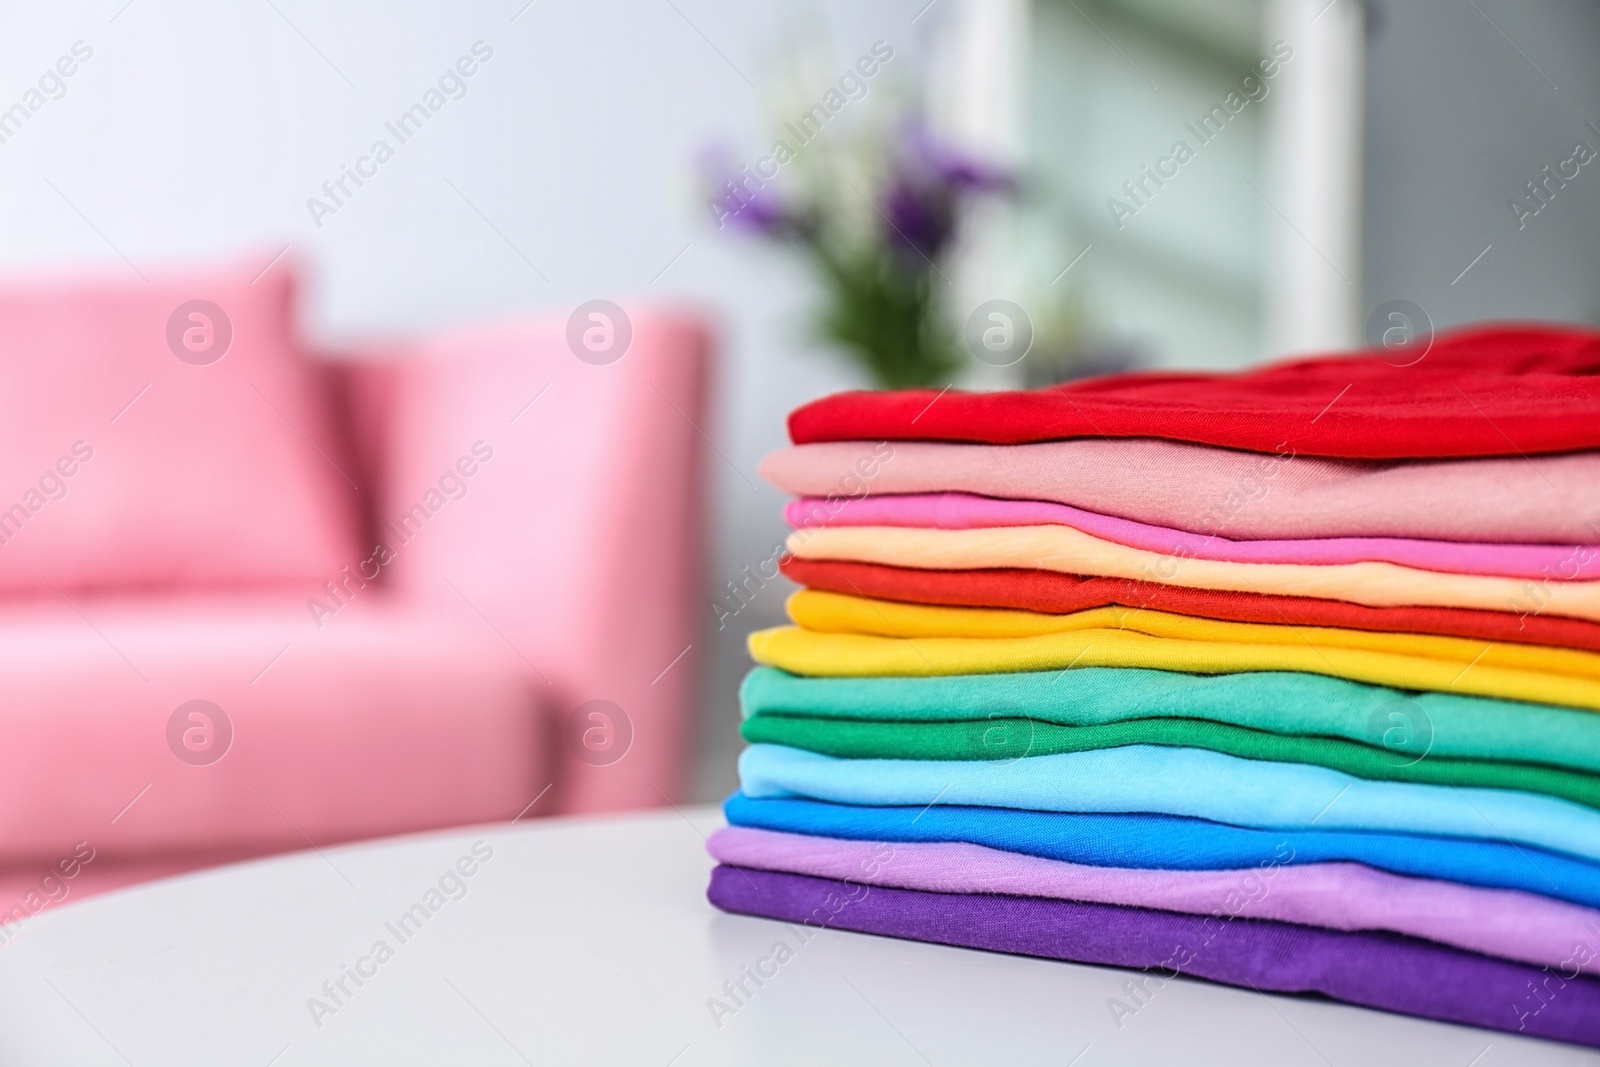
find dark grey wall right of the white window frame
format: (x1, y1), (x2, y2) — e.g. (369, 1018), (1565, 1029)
(1363, 0), (1600, 325)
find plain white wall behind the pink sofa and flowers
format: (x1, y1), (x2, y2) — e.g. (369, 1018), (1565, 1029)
(0, 0), (939, 795)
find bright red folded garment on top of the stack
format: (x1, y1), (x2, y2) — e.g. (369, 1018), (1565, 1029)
(789, 325), (1600, 459)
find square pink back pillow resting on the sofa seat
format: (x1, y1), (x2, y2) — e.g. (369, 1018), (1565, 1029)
(0, 258), (357, 597)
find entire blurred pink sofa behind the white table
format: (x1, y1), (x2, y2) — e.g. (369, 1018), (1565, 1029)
(0, 260), (709, 921)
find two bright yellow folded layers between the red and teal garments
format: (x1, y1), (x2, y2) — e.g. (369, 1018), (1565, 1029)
(750, 590), (1600, 710)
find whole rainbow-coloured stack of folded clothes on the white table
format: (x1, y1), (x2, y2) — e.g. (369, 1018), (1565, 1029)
(710, 328), (1600, 1045)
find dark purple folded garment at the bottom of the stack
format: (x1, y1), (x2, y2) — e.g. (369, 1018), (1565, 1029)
(706, 865), (1600, 1048)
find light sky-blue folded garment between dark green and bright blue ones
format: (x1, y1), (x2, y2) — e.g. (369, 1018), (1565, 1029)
(739, 744), (1600, 861)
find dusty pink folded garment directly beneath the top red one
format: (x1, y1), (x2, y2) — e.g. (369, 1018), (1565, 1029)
(762, 438), (1600, 547)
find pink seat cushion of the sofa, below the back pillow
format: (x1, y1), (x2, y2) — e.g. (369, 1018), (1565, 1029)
(0, 593), (547, 857)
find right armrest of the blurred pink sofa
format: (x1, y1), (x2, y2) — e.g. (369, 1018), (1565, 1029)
(374, 312), (710, 811)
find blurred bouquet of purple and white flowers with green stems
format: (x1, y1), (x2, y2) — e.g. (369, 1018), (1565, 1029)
(709, 118), (1014, 389)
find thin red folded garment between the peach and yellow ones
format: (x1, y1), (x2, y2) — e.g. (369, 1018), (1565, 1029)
(779, 557), (1600, 651)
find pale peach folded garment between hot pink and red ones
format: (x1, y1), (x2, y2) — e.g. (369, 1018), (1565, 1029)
(789, 525), (1600, 622)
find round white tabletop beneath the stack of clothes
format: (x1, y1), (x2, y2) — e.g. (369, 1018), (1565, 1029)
(0, 808), (1574, 1067)
